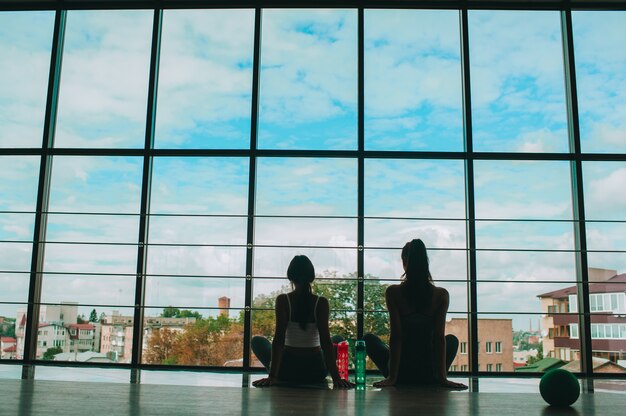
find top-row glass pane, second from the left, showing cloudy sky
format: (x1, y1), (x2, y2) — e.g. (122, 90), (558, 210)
(55, 10), (153, 148)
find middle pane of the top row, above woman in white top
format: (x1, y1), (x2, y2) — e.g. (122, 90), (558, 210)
(258, 9), (357, 149)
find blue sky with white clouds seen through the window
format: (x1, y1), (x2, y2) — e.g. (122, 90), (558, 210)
(0, 10), (626, 354)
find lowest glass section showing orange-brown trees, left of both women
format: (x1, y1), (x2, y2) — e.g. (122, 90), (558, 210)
(142, 308), (243, 367)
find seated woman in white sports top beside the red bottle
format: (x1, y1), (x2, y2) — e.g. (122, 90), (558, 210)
(252, 256), (354, 388)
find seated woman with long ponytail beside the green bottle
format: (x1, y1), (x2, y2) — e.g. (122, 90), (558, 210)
(364, 239), (467, 389)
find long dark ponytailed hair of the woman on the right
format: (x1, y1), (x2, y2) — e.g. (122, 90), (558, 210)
(402, 238), (434, 306)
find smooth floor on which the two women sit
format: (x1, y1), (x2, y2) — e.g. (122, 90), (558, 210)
(0, 380), (626, 416)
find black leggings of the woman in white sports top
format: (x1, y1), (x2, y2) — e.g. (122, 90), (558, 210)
(250, 335), (343, 383)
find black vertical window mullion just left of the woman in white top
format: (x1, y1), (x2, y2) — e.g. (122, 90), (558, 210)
(242, 7), (262, 374)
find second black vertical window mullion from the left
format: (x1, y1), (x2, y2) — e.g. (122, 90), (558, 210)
(130, 9), (163, 383)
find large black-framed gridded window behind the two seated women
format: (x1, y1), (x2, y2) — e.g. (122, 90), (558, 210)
(0, 0), (626, 379)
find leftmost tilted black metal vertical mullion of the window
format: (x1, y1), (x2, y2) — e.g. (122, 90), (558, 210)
(22, 10), (67, 379)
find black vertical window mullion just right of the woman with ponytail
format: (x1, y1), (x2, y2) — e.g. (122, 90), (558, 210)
(459, 9), (478, 391)
